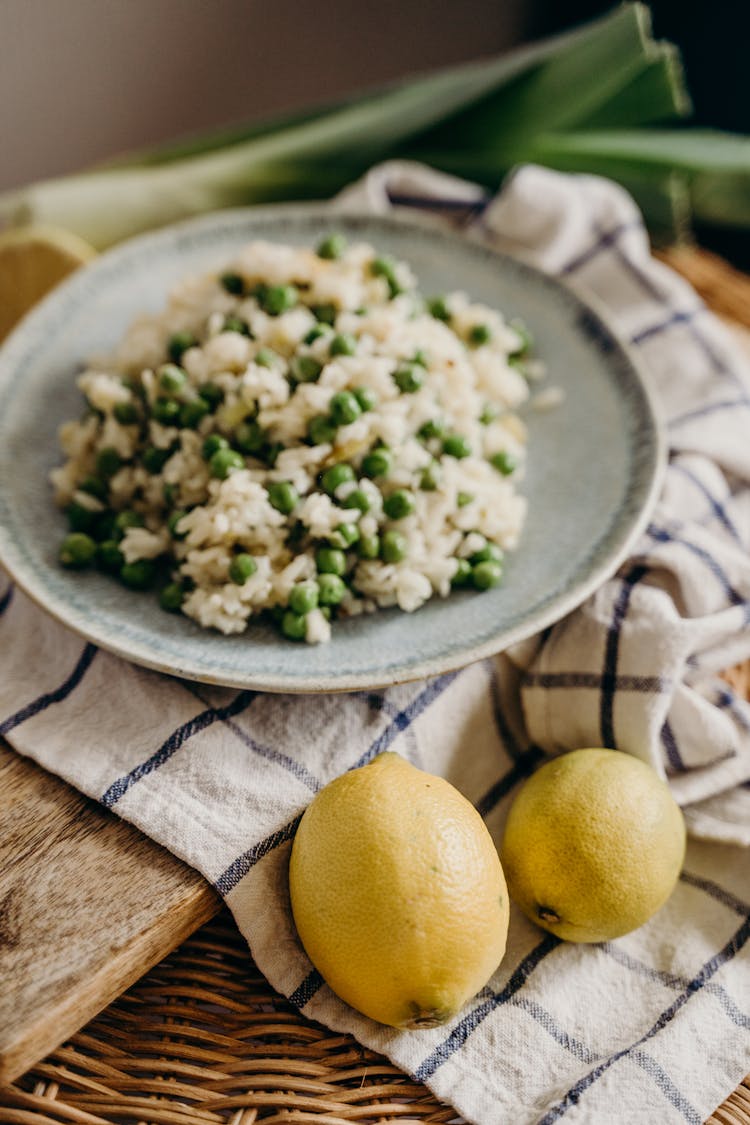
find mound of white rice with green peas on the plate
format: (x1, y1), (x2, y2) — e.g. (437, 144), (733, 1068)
(52, 234), (540, 644)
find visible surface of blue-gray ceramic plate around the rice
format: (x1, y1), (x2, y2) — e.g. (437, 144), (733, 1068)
(0, 206), (663, 692)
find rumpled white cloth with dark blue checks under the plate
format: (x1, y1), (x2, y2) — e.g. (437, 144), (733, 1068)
(0, 163), (750, 1125)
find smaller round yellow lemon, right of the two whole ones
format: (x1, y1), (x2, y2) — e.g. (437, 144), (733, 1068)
(500, 749), (685, 942)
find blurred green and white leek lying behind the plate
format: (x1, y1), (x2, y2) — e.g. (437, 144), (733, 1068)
(0, 3), (750, 248)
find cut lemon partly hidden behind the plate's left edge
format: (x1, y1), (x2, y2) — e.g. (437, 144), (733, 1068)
(0, 226), (97, 340)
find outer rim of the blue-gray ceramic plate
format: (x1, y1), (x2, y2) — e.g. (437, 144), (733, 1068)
(0, 201), (667, 694)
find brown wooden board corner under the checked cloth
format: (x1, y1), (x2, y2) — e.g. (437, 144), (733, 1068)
(0, 740), (219, 1081)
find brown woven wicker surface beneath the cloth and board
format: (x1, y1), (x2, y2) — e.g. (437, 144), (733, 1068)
(0, 250), (750, 1125)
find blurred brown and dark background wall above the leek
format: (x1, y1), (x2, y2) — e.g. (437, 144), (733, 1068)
(0, 0), (750, 252)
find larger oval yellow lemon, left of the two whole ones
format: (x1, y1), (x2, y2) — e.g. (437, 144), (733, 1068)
(289, 753), (508, 1028)
